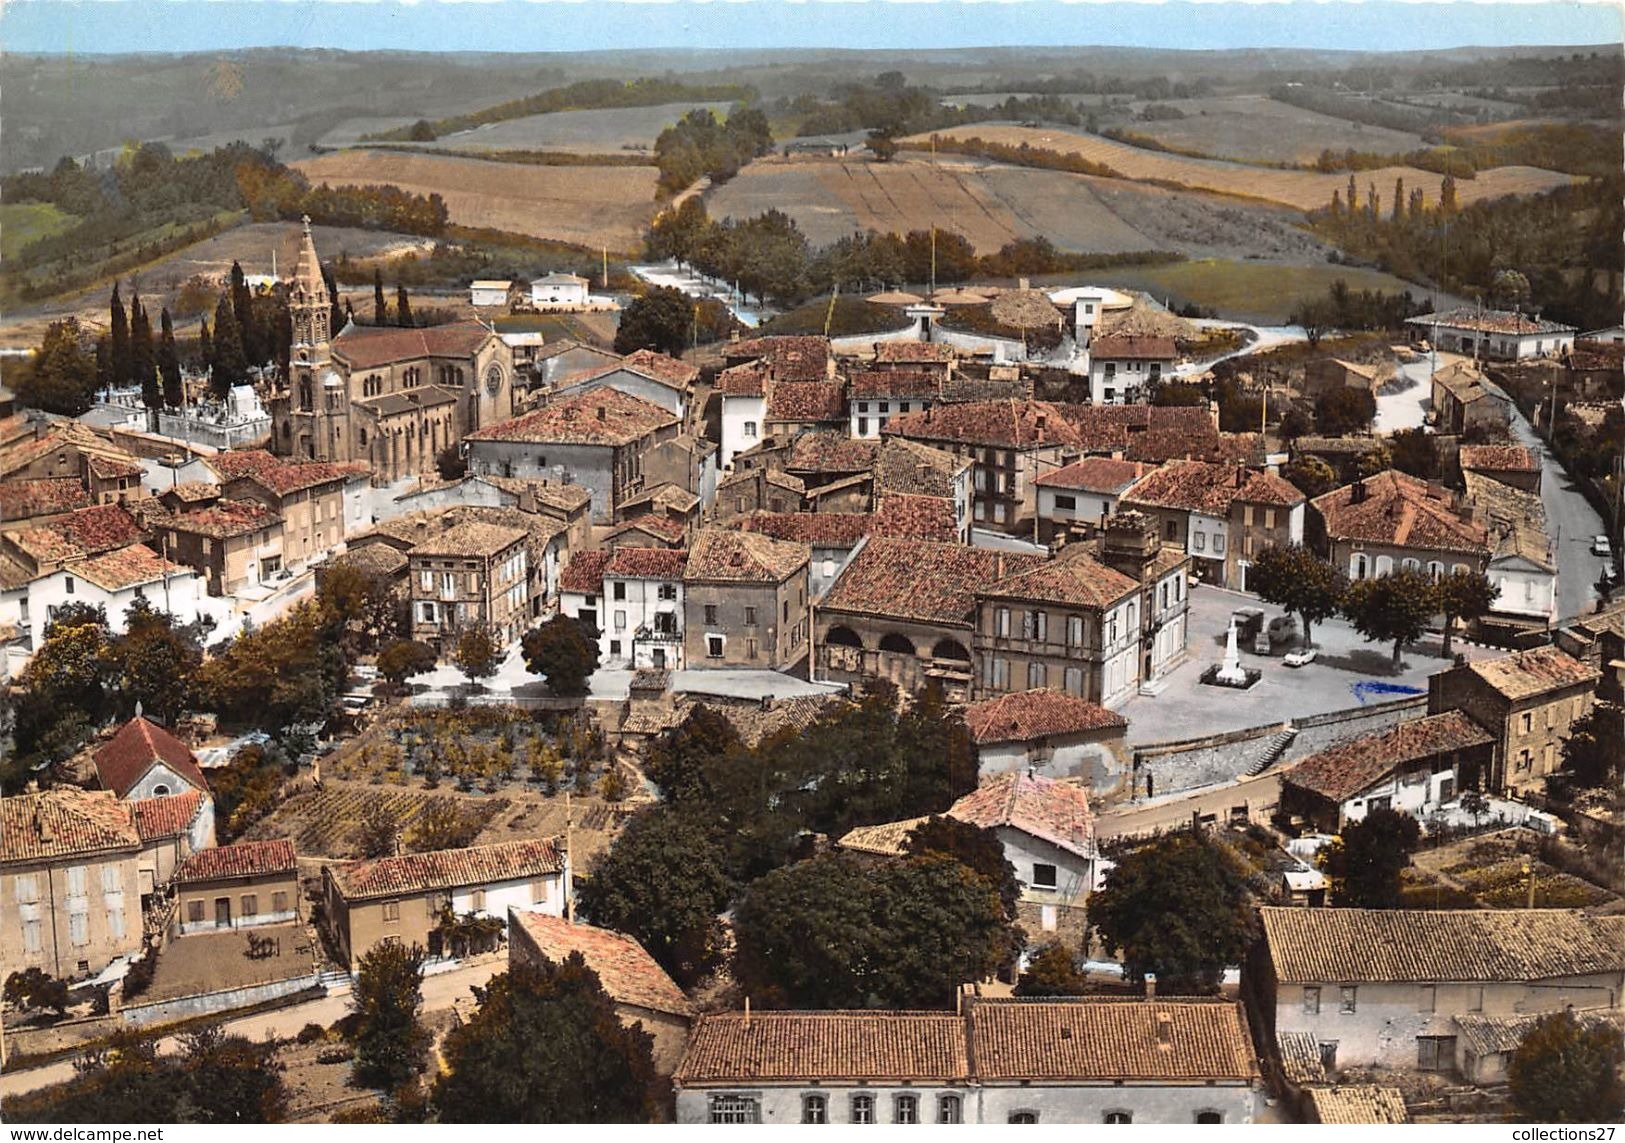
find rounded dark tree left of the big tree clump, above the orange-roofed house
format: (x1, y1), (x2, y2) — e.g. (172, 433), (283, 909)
(580, 806), (731, 989)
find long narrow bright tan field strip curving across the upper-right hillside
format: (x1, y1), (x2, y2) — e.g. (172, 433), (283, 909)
(904, 124), (1571, 210)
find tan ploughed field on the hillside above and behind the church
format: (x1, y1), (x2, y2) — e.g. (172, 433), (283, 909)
(293, 150), (657, 252)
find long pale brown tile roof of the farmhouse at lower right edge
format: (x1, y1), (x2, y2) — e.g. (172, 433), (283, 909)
(1259, 907), (1625, 984)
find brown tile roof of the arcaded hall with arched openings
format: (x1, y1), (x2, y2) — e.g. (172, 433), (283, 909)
(819, 537), (1043, 628)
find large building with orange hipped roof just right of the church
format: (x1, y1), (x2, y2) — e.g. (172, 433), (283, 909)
(468, 389), (679, 524)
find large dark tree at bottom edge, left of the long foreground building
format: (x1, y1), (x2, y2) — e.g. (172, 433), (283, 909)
(432, 953), (665, 1123)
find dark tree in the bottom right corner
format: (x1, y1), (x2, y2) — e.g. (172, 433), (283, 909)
(1506, 1010), (1625, 1123)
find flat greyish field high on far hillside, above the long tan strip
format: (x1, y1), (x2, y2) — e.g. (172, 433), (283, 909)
(1123, 96), (1427, 163)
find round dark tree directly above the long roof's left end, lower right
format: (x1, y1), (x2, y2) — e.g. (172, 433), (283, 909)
(1089, 832), (1251, 993)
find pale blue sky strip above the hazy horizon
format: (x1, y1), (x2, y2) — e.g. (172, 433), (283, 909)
(0, 0), (1622, 54)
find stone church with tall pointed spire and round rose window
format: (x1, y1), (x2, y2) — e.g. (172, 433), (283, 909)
(270, 218), (514, 485)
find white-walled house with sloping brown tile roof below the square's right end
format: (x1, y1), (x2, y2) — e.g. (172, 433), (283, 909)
(1281, 711), (1493, 834)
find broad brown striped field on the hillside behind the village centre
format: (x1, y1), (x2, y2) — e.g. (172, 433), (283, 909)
(705, 154), (1324, 260)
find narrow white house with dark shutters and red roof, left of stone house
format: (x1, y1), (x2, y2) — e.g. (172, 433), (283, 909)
(607, 548), (689, 670)
